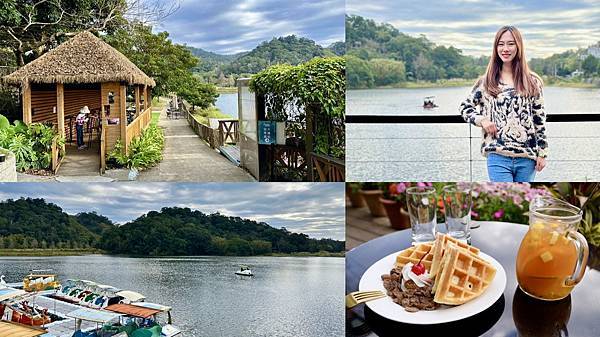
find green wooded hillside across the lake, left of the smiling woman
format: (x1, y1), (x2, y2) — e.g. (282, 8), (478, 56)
(346, 16), (487, 89)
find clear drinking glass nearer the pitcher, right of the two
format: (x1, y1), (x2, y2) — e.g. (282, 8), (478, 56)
(443, 185), (472, 243)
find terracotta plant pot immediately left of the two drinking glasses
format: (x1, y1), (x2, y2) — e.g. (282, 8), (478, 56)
(379, 182), (410, 229)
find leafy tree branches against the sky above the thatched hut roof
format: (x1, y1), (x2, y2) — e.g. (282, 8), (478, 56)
(0, 0), (179, 66)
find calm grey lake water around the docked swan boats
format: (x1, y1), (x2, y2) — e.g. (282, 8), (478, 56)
(0, 255), (345, 337)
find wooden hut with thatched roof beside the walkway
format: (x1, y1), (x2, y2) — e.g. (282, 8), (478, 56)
(3, 32), (156, 170)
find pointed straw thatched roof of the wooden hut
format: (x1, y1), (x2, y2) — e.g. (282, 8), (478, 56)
(4, 31), (156, 87)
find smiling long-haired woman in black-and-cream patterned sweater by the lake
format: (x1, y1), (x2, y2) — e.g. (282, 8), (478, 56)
(460, 26), (548, 182)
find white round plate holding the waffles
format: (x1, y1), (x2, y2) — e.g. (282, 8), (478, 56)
(358, 252), (506, 324)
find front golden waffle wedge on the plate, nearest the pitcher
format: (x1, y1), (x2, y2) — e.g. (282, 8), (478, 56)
(433, 243), (496, 305)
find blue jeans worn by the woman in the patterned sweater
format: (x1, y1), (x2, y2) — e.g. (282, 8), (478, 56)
(488, 153), (536, 182)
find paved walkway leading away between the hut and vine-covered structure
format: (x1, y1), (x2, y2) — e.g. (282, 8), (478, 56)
(138, 111), (254, 182)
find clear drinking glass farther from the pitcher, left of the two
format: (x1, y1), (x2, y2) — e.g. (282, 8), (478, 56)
(406, 186), (437, 244)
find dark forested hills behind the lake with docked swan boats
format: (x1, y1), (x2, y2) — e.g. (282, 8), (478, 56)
(0, 198), (344, 255)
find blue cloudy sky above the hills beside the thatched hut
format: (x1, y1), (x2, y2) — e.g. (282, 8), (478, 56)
(155, 0), (345, 54)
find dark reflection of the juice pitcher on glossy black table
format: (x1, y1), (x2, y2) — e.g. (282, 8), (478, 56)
(512, 287), (571, 337)
